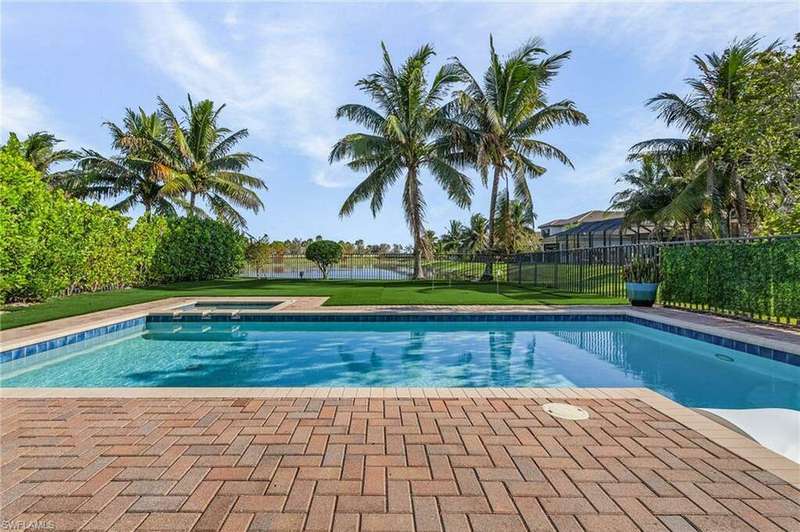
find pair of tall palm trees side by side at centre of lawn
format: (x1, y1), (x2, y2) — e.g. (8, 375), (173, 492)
(330, 37), (588, 278)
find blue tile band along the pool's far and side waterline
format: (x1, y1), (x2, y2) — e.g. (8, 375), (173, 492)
(0, 313), (800, 366)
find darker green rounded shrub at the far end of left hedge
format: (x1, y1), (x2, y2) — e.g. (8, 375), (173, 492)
(147, 217), (246, 283)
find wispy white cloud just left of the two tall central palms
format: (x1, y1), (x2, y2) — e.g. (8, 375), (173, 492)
(137, 4), (349, 187)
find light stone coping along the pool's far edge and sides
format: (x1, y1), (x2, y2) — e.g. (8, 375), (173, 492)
(0, 296), (800, 365)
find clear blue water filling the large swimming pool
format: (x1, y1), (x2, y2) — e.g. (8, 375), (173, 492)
(0, 321), (800, 410)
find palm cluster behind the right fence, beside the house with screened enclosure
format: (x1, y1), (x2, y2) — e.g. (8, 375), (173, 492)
(624, 36), (779, 238)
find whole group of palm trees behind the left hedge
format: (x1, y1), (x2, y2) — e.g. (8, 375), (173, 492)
(15, 96), (266, 228)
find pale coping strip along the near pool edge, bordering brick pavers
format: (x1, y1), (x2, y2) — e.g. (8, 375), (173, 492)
(0, 387), (800, 487)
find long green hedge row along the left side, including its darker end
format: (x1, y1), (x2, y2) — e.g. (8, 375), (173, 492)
(0, 149), (245, 301)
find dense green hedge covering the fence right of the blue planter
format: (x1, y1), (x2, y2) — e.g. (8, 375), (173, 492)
(661, 238), (800, 323)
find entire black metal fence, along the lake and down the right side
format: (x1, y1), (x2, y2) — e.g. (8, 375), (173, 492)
(242, 235), (800, 326)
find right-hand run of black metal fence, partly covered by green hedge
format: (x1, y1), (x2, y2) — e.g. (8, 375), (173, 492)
(507, 235), (800, 326)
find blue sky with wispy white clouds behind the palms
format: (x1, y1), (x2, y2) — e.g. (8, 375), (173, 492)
(0, 0), (800, 243)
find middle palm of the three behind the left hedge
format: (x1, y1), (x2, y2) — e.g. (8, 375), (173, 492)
(78, 108), (188, 218)
